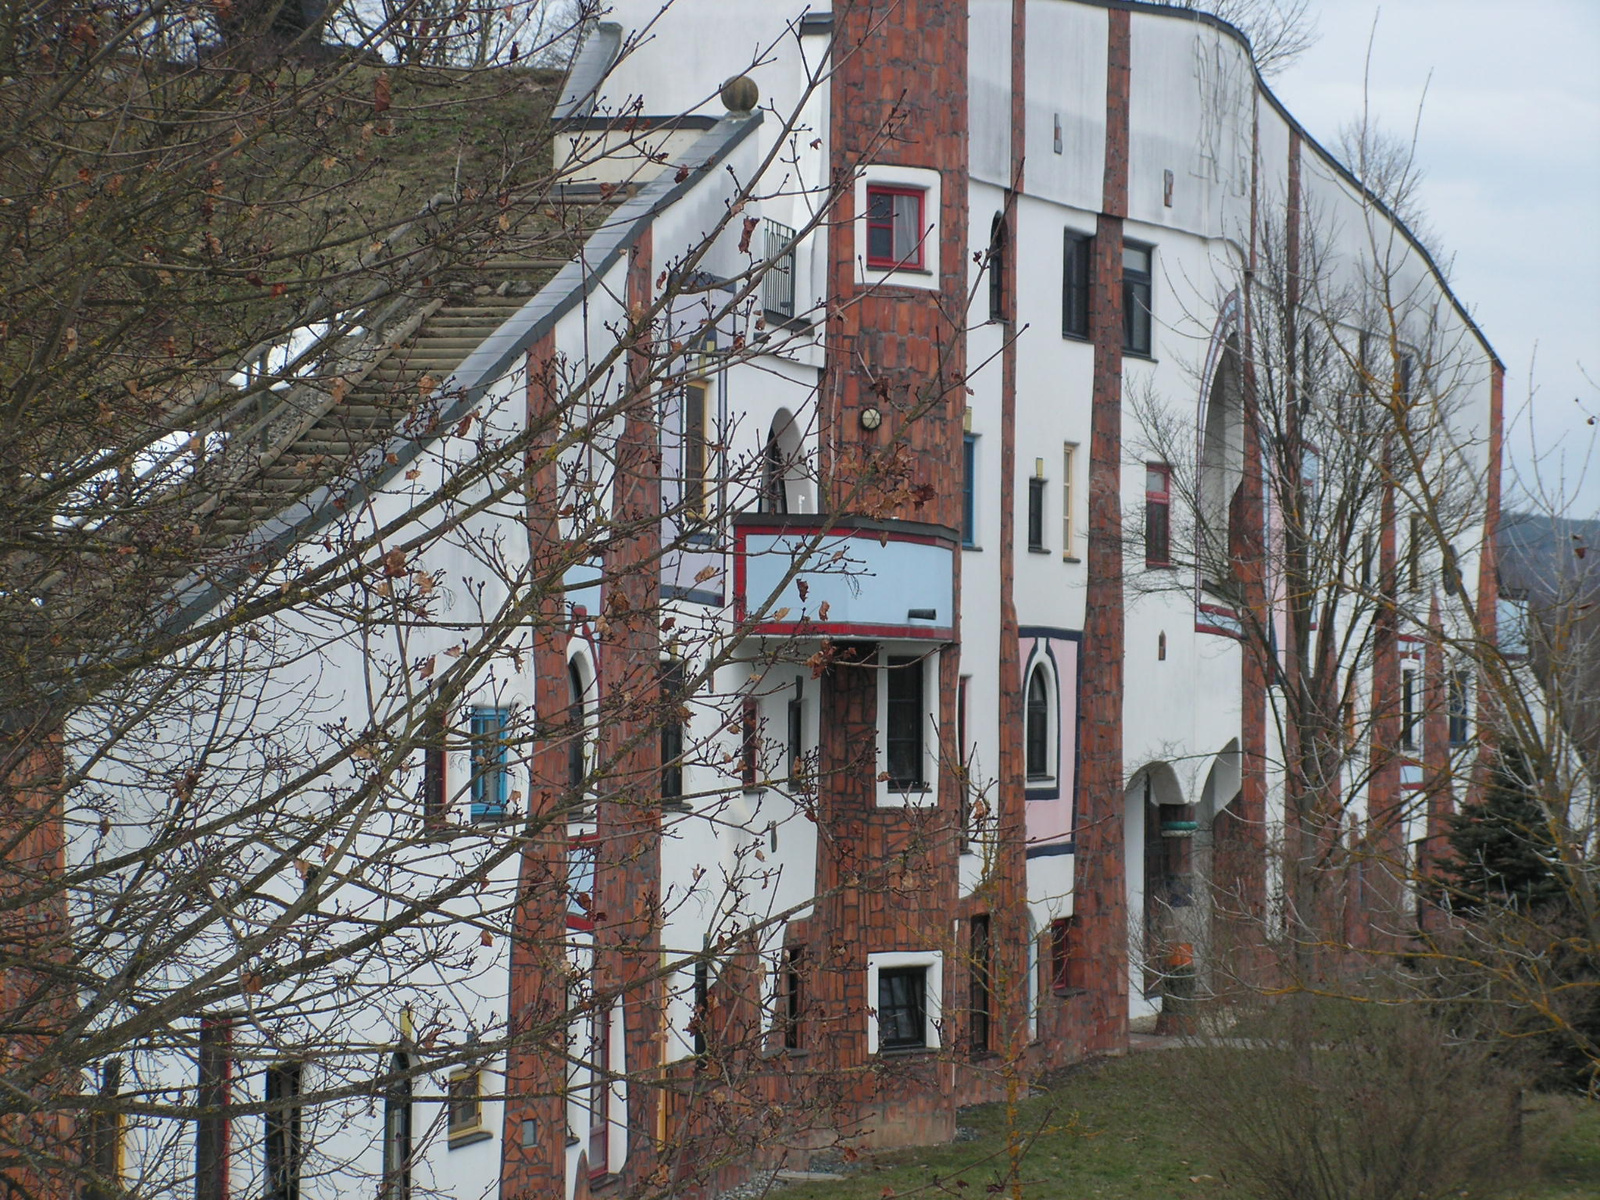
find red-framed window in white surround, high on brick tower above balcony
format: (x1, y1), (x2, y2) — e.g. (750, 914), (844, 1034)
(854, 165), (941, 291)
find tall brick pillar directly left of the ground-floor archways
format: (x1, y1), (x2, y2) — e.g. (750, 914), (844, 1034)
(1074, 8), (1130, 1053)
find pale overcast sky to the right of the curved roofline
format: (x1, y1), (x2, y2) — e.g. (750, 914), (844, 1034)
(1272, 0), (1600, 517)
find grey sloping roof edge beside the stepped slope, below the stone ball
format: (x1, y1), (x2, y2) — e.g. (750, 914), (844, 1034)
(158, 109), (762, 629)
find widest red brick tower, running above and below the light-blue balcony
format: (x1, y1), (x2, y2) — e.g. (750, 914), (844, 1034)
(819, 0), (968, 1142)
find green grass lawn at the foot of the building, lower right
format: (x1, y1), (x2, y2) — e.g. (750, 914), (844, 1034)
(779, 1050), (1600, 1200)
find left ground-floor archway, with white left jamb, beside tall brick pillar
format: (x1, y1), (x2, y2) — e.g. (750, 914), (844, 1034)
(1123, 762), (1190, 1019)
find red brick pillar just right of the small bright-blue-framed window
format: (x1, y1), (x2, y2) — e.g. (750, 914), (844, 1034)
(501, 334), (573, 1200)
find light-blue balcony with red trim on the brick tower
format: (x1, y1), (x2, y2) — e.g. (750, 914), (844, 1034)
(733, 514), (960, 642)
